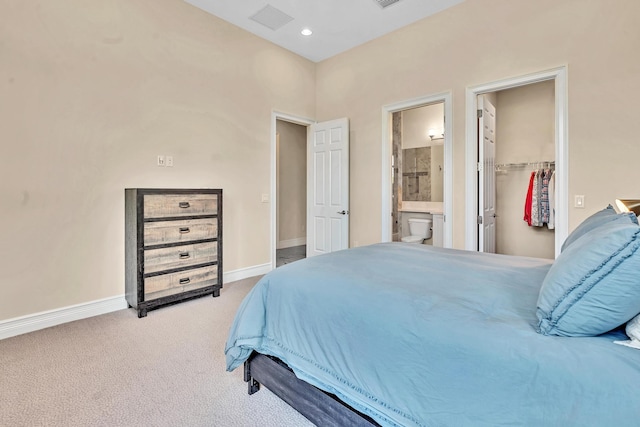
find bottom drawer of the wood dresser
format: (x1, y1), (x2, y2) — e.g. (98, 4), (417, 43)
(144, 265), (218, 300)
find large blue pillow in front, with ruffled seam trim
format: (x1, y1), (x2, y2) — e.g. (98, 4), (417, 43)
(536, 221), (640, 337)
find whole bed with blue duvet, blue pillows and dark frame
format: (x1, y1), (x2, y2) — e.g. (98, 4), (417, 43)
(225, 208), (640, 426)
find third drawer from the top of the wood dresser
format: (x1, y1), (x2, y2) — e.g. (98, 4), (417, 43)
(144, 242), (218, 273)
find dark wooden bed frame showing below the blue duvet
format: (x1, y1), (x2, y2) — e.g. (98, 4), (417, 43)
(244, 352), (380, 427)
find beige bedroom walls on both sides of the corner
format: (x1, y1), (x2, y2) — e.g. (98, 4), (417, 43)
(0, 0), (640, 320)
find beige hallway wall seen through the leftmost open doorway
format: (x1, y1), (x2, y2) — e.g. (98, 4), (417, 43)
(276, 120), (307, 248)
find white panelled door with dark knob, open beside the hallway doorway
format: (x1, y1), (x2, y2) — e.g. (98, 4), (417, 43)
(307, 118), (349, 257)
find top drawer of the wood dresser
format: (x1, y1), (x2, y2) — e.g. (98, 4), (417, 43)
(144, 194), (218, 218)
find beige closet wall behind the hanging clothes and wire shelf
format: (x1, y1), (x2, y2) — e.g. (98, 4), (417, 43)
(495, 81), (555, 259)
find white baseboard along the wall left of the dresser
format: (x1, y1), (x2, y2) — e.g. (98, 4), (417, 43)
(0, 295), (128, 340)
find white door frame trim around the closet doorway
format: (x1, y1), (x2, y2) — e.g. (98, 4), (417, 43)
(465, 65), (569, 258)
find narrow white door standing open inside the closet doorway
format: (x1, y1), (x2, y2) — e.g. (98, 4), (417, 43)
(478, 96), (496, 253)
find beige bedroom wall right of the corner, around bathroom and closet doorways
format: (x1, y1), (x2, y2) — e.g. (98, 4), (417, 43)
(316, 0), (640, 248)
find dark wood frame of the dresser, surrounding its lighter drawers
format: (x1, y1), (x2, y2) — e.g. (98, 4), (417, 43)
(125, 188), (223, 318)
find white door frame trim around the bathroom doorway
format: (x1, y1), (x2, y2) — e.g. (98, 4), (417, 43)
(380, 91), (453, 248)
